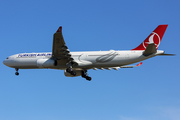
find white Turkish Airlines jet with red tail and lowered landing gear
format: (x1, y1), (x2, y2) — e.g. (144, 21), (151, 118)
(3, 25), (173, 81)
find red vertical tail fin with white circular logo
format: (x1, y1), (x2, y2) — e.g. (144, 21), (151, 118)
(132, 25), (168, 50)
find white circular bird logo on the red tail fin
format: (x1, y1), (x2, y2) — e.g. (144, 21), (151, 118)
(143, 32), (161, 49)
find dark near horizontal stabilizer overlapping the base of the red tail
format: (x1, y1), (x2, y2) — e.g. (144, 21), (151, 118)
(143, 43), (157, 56)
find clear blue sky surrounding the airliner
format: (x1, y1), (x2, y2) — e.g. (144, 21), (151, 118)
(0, 0), (180, 120)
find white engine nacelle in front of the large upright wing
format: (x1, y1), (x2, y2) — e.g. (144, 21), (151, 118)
(36, 59), (57, 68)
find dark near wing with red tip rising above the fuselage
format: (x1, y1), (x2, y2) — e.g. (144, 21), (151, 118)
(52, 26), (74, 65)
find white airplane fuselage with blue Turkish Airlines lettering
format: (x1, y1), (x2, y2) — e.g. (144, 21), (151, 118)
(3, 50), (164, 70)
